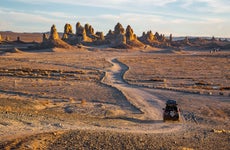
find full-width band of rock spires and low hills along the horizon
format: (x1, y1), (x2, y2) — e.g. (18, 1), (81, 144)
(0, 22), (229, 49)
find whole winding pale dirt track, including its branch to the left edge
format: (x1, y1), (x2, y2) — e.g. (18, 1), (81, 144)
(0, 58), (187, 147)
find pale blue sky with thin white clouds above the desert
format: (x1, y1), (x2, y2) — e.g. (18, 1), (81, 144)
(0, 0), (230, 38)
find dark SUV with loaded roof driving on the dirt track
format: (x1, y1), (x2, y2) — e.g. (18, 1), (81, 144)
(163, 100), (179, 121)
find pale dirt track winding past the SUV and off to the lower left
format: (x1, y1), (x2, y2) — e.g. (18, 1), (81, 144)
(0, 58), (185, 149)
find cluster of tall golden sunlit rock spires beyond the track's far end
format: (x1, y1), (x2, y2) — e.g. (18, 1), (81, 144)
(37, 22), (185, 48)
